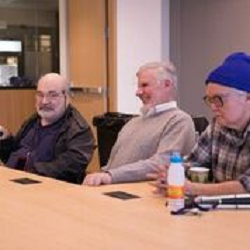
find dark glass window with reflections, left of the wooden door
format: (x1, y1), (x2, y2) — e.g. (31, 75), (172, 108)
(0, 0), (59, 87)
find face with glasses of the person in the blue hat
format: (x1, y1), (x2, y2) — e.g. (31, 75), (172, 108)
(205, 82), (250, 130)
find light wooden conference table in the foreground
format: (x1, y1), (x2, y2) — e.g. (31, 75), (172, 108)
(0, 167), (250, 250)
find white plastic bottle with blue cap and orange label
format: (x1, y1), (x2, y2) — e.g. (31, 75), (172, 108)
(167, 152), (185, 213)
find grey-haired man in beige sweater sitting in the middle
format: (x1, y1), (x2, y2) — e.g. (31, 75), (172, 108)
(83, 62), (195, 186)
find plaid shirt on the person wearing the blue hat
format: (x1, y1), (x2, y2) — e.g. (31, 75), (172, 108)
(188, 121), (250, 192)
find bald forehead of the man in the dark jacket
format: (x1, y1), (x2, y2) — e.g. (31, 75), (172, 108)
(37, 75), (67, 92)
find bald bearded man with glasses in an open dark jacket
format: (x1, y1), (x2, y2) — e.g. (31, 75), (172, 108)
(0, 73), (94, 184)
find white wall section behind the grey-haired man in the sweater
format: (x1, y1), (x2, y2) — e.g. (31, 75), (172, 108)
(117, 0), (169, 113)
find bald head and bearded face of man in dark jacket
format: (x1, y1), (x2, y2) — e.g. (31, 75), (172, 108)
(36, 73), (69, 125)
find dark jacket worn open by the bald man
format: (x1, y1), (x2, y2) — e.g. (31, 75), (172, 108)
(0, 105), (94, 184)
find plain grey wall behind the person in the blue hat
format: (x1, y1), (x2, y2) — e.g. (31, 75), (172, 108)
(170, 0), (250, 117)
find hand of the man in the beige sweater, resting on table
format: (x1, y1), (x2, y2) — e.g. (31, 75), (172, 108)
(83, 172), (112, 186)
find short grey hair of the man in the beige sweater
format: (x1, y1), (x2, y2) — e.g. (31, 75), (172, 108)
(137, 61), (178, 89)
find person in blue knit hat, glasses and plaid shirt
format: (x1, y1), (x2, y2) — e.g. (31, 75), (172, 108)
(152, 52), (250, 195)
